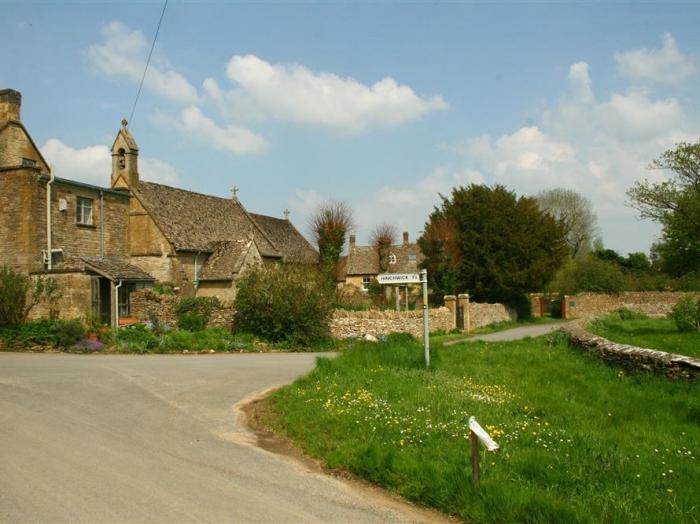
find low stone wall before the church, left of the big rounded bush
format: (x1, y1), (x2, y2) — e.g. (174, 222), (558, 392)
(129, 289), (235, 329)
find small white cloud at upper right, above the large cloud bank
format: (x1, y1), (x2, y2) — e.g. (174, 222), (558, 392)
(615, 33), (696, 84)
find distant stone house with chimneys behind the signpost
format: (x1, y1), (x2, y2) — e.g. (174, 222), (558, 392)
(337, 232), (424, 292)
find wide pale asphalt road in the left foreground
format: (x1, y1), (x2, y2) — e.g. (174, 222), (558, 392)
(0, 353), (432, 523)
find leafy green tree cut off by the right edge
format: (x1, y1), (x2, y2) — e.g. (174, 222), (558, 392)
(627, 140), (700, 276)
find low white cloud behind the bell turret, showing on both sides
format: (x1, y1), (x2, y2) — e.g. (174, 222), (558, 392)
(40, 138), (178, 187)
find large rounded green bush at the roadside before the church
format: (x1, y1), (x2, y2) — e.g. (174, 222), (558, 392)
(234, 264), (333, 346)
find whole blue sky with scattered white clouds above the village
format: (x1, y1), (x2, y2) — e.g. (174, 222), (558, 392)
(0, 0), (700, 254)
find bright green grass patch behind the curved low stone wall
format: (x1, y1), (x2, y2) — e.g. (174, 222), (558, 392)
(588, 315), (700, 358)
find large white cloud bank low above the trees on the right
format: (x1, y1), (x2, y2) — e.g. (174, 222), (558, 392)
(440, 54), (700, 255)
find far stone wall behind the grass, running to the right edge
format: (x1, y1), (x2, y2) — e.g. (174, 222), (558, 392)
(564, 291), (700, 318)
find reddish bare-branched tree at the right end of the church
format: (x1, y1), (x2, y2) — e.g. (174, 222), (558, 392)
(309, 201), (353, 274)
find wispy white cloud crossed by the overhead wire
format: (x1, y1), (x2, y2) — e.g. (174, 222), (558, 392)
(87, 22), (199, 103)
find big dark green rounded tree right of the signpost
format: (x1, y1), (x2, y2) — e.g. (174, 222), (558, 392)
(418, 184), (569, 302)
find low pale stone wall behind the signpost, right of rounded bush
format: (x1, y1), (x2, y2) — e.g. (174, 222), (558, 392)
(331, 307), (455, 338)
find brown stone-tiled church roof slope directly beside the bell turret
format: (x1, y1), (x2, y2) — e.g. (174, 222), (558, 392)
(134, 182), (282, 258)
